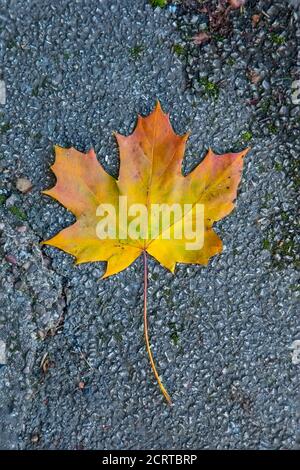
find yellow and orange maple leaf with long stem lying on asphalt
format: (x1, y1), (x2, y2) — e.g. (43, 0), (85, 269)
(43, 102), (248, 402)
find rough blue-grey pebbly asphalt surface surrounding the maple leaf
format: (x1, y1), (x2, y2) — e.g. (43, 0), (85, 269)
(0, 0), (300, 449)
